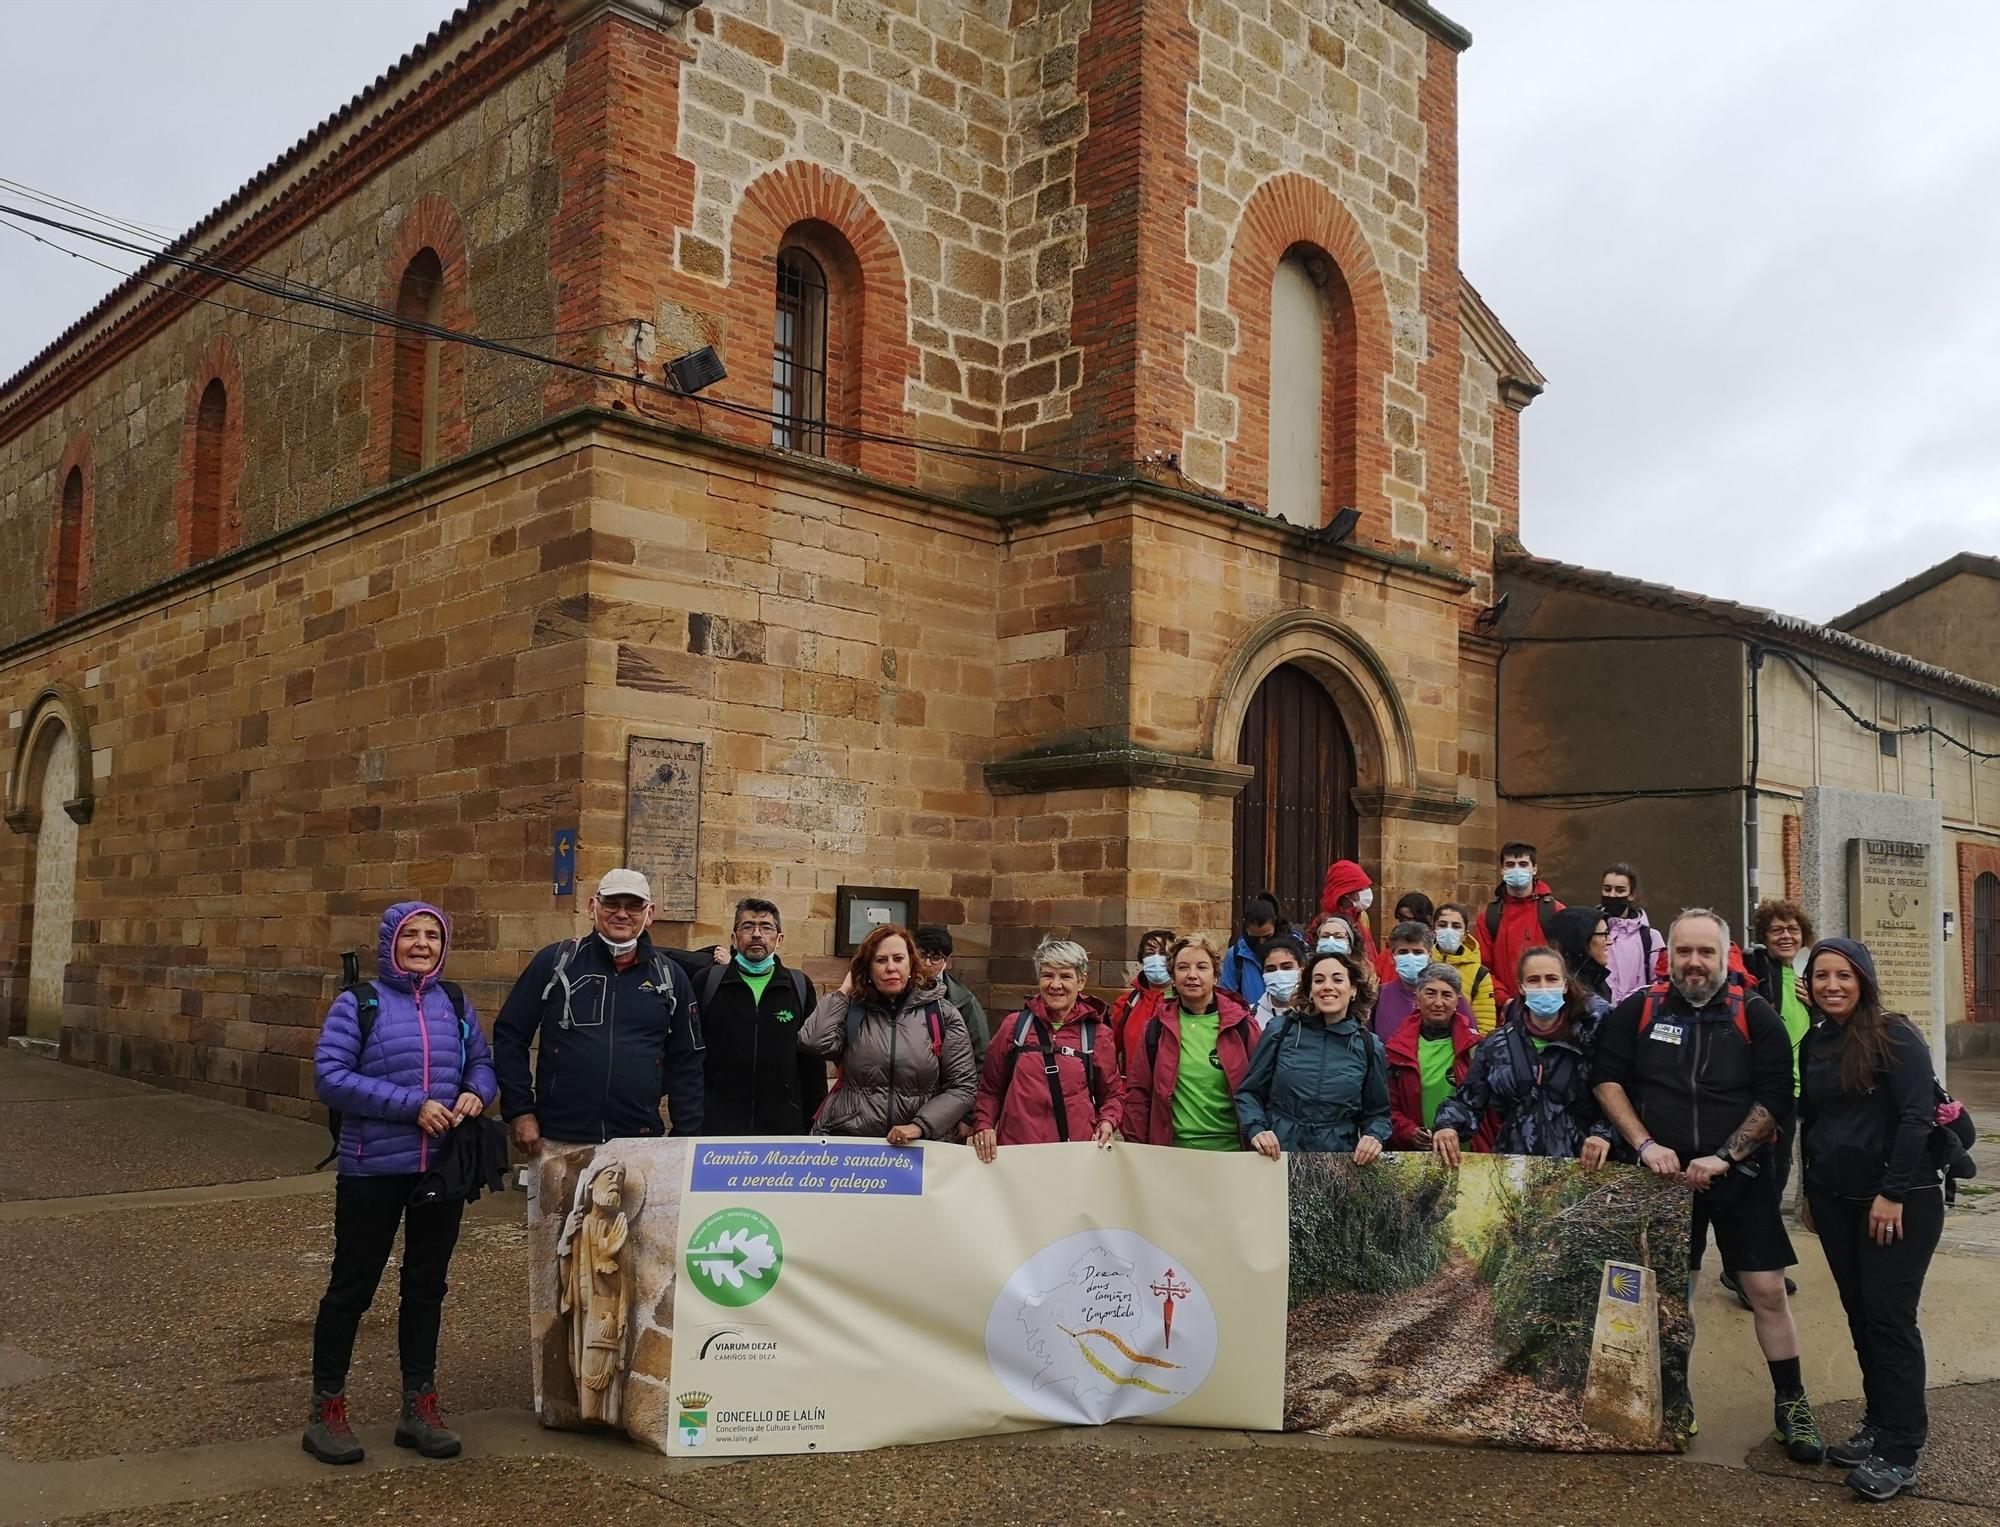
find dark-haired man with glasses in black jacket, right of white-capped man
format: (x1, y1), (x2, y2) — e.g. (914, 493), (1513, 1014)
(696, 895), (826, 1135)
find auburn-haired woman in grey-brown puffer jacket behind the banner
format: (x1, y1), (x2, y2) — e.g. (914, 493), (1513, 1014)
(798, 927), (978, 1145)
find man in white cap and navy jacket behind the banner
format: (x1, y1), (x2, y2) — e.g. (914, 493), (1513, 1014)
(494, 869), (702, 1155)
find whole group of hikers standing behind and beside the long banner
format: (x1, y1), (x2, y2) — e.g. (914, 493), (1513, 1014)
(304, 843), (1946, 1499)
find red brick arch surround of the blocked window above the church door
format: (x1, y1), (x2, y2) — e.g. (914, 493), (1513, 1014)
(1228, 174), (1392, 542)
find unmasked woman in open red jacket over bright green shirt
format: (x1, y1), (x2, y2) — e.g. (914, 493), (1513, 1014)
(1124, 933), (1258, 1151)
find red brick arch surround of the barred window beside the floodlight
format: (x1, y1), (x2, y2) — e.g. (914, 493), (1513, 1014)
(722, 160), (916, 482)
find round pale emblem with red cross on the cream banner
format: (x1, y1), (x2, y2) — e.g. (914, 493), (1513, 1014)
(986, 1229), (1218, 1425)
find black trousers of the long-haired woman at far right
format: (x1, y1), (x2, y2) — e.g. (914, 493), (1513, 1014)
(1806, 1187), (1944, 1467)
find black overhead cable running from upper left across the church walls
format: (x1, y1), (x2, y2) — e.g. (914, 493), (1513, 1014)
(0, 202), (1132, 486)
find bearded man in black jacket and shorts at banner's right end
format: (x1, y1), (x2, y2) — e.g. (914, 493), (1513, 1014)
(1592, 907), (1826, 1463)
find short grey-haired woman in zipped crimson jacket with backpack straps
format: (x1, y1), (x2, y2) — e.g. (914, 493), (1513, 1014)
(972, 939), (1124, 1161)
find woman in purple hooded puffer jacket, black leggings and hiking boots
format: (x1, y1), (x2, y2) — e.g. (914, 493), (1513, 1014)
(302, 901), (498, 1463)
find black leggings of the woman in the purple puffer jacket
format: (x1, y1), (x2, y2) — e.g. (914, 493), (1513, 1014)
(312, 1173), (466, 1395)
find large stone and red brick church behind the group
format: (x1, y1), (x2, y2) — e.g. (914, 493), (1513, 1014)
(0, 0), (1542, 1113)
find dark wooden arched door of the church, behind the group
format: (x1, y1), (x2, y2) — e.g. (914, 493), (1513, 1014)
(1230, 664), (1360, 923)
